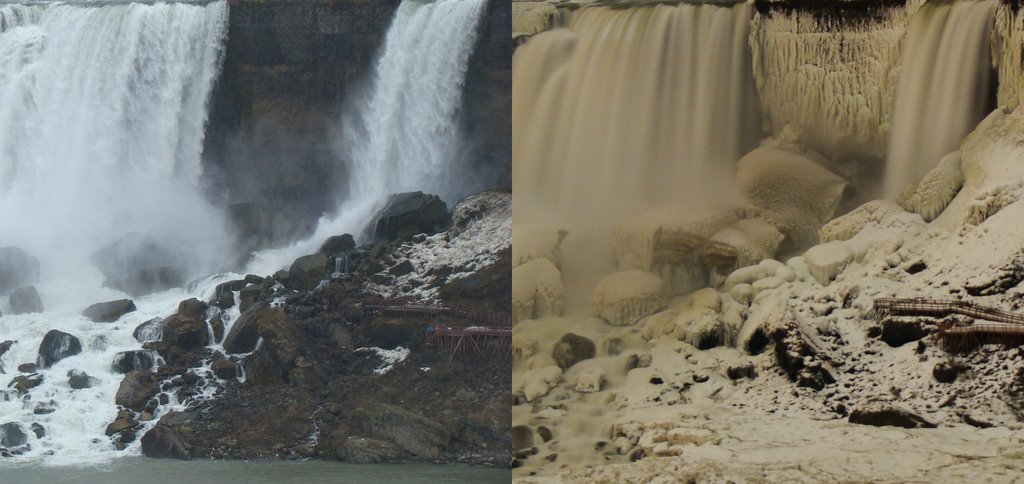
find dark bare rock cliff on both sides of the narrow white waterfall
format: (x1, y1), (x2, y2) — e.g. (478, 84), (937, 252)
(205, 0), (512, 248)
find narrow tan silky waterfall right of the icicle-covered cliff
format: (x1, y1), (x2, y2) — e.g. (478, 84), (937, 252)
(885, 0), (996, 200)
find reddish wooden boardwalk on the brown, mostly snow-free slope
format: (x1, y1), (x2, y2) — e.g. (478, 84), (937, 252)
(362, 298), (512, 361)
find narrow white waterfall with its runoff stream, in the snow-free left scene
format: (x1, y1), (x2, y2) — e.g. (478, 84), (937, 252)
(249, 0), (486, 273)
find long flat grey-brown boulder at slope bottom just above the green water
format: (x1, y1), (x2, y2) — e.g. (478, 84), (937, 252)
(353, 403), (452, 459)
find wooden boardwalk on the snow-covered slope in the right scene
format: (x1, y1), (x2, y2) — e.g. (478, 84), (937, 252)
(873, 298), (1024, 352)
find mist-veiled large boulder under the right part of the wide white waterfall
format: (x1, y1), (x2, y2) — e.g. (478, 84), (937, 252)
(92, 232), (188, 296)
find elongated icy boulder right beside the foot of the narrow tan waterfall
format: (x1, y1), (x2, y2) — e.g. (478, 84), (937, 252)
(899, 151), (964, 222)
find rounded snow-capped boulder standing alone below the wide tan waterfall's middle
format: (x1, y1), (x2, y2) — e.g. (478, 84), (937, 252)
(593, 270), (668, 326)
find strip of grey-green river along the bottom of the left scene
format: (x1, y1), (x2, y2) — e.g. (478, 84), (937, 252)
(0, 457), (512, 484)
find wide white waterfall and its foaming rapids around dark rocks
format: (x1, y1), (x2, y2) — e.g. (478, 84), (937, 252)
(0, 1), (232, 464)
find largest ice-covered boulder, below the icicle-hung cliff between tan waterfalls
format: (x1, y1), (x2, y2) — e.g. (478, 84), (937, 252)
(736, 147), (848, 248)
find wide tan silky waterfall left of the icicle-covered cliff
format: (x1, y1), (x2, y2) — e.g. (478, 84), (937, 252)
(512, 4), (759, 224)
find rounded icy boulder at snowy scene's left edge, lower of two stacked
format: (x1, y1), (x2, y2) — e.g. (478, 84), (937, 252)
(512, 259), (563, 321)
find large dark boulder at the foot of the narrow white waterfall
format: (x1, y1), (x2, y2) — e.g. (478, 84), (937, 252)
(369, 191), (451, 240)
